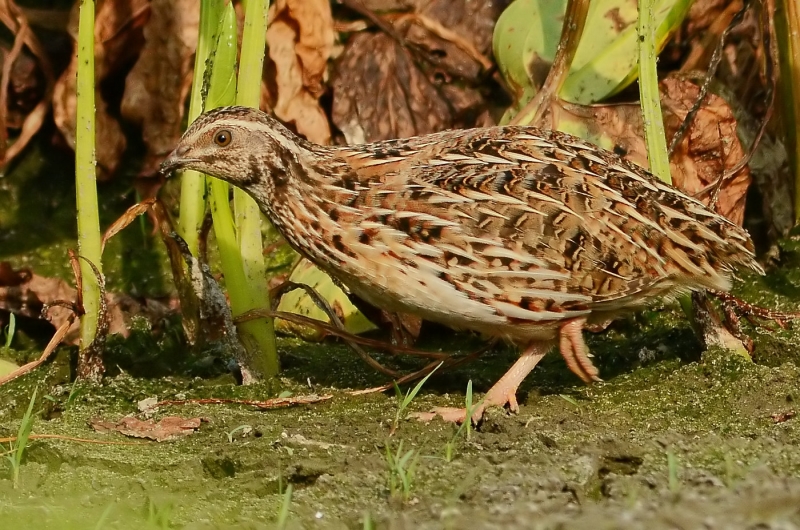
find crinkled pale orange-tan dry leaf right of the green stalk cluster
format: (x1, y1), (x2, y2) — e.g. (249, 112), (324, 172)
(267, 0), (334, 144)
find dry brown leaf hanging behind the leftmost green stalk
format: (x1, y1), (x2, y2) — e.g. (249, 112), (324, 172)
(53, 0), (148, 180)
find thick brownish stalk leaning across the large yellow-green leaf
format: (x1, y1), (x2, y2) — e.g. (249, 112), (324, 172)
(509, 0), (589, 128)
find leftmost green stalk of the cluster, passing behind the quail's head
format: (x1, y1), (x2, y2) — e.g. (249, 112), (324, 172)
(178, 0), (225, 256)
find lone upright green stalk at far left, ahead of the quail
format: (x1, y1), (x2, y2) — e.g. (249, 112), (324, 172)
(75, 0), (102, 348)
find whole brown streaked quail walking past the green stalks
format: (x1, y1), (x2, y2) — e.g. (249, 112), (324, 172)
(162, 107), (761, 416)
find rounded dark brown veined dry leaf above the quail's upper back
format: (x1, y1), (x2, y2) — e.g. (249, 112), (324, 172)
(331, 32), (452, 144)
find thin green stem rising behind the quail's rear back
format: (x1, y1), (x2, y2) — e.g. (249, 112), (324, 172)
(637, 0), (672, 184)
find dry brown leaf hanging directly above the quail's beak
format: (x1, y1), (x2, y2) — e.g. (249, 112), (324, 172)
(121, 0), (200, 176)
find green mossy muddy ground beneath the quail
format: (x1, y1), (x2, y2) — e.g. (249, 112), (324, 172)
(0, 135), (800, 529)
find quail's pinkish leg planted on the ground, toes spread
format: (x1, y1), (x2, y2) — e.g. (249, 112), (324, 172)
(417, 342), (551, 423)
